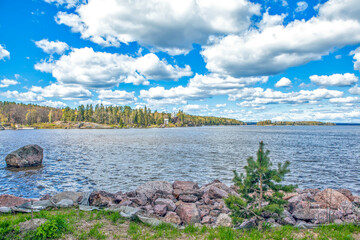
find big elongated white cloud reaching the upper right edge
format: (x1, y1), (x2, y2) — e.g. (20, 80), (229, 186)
(202, 0), (360, 77)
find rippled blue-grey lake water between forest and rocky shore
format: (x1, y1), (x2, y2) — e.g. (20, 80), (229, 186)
(0, 126), (360, 197)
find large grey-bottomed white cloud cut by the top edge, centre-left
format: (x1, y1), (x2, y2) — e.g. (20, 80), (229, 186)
(56, 0), (260, 55)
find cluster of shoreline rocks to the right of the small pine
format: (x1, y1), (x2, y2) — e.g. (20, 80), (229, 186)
(238, 188), (360, 228)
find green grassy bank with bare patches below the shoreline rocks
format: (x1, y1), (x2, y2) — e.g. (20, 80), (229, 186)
(0, 208), (360, 240)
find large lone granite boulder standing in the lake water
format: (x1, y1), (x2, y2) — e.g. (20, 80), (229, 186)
(5, 144), (44, 168)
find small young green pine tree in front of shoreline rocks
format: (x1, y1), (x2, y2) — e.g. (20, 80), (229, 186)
(225, 141), (295, 223)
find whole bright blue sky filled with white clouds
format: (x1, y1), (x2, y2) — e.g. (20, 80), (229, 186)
(0, 0), (360, 122)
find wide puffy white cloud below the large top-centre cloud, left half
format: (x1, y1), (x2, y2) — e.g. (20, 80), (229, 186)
(35, 47), (192, 88)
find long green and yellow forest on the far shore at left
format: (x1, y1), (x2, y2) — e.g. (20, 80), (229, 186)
(0, 101), (245, 128)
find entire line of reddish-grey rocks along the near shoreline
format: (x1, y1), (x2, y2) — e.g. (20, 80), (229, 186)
(0, 180), (360, 229)
